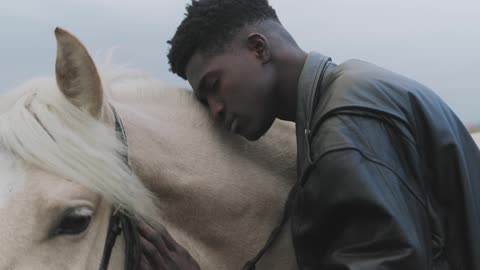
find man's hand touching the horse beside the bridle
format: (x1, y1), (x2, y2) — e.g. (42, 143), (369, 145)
(139, 222), (200, 270)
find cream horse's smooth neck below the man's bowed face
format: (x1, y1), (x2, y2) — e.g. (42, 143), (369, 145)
(109, 87), (296, 268)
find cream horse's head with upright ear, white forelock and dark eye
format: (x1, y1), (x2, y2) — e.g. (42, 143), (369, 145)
(0, 29), (156, 269)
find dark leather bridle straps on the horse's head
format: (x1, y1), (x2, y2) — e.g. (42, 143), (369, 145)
(99, 105), (141, 270)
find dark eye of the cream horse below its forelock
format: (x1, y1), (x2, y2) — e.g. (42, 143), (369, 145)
(53, 208), (93, 235)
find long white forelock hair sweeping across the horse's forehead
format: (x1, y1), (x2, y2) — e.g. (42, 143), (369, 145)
(0, 68), (158, 222)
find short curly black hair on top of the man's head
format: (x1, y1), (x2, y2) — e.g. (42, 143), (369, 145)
(167, 0), (280, 80)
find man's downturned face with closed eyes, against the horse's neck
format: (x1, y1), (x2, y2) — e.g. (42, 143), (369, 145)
(186, 48), (277, 140)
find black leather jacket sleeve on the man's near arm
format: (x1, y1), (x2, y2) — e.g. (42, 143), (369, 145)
(292, 148), (430, 270)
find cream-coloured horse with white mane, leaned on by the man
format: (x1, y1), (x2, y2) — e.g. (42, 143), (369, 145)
(0, 29), (296, 270)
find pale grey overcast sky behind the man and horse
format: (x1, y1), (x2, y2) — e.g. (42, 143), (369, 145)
(0, 0), (480, 123)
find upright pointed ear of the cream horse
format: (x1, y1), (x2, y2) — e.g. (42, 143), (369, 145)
(55, 27), (103, 117)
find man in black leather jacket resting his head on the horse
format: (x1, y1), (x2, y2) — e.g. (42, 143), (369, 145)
(143, 0), (480, 269)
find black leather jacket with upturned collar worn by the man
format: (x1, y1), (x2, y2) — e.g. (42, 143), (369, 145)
(292, 53), (480, 270)
